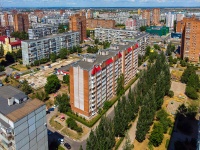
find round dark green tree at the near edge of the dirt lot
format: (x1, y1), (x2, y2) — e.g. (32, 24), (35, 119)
(44, 75), (61, 94)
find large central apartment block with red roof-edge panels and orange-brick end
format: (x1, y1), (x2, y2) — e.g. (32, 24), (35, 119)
(70, 42), (138, 118)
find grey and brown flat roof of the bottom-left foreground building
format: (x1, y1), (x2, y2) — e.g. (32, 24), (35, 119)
(0, 86), (45, 122)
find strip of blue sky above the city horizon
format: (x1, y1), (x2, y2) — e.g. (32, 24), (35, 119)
(0, 0), (200, 7)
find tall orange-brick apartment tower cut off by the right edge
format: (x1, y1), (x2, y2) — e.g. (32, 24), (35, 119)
(177, 15), (200, 62)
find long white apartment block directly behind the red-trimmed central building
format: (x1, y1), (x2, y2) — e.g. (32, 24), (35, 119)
(95, 28), (149, 54)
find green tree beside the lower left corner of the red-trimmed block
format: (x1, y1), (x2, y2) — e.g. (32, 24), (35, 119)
(55, 94), (71, 113)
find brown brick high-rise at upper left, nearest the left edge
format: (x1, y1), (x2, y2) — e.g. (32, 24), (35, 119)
(14, 14), (29, 32)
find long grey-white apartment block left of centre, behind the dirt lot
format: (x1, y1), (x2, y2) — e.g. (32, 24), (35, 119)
(21, 32), (80, 65)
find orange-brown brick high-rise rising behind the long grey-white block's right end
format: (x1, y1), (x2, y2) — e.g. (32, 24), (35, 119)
(69, 14), (87, 41)
